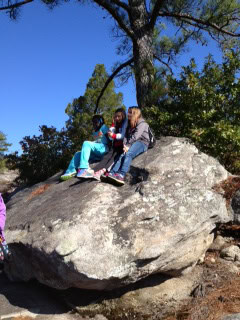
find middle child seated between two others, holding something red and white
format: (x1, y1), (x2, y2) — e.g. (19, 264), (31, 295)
(93, 108), (128, 181)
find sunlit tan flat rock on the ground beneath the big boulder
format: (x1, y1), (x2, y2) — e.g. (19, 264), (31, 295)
(67, 266), (203, 320)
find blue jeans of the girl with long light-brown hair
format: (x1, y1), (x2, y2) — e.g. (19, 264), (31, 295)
(110, 141), (147, 177)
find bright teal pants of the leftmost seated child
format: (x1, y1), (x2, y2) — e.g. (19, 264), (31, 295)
(66, 141), (108, 173)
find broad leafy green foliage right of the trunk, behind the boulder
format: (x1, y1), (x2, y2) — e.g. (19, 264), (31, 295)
(145, 51), (240, 174)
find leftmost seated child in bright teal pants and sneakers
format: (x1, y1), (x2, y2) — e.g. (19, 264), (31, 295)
(60, 115), (109, 181)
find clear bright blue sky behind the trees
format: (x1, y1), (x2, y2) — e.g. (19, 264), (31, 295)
(0, 2), (220, 152)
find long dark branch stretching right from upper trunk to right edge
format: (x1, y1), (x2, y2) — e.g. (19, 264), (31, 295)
(159, 11), (240, 37)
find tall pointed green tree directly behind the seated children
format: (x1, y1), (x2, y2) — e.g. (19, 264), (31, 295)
(65, 64), (123, 151)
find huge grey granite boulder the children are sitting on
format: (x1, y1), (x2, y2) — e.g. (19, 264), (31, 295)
(3, 137), (232, 290)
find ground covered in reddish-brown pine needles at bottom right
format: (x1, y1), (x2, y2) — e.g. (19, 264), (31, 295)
(162, 224), (240, 320)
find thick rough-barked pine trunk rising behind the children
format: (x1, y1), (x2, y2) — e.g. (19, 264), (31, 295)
(129, 0), (154, 108)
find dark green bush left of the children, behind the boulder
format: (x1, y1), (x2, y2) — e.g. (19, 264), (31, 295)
(8, 125), (72, 184)
